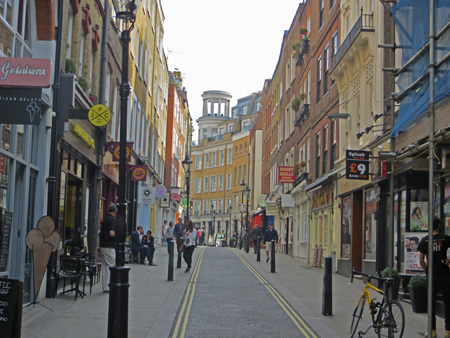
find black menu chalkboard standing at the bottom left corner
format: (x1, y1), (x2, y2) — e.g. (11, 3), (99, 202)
(0, 278), (23, 338)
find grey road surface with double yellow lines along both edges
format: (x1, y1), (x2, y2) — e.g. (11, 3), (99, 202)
(171, 248), (317, 337)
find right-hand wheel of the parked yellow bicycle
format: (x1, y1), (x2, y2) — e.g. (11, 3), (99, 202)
(378, 300), (405, 338)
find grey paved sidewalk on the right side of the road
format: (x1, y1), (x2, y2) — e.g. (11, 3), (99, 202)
(236, 249), (444, 338)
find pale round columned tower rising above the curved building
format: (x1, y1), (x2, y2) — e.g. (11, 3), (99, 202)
(197, 90), (232, 141)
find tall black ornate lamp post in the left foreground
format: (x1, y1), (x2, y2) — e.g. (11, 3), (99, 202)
(108, 0), (141, 338)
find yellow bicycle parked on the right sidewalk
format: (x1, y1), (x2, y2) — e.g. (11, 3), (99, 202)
(350, 269), (405, 338)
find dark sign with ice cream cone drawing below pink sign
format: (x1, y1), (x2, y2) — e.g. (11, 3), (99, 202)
(0, 88), (42, 125)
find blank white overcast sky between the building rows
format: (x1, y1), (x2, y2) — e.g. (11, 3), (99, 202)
(162, 0), (303, 139)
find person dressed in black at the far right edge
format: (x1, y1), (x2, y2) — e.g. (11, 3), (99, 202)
(418, 218), (450, 338)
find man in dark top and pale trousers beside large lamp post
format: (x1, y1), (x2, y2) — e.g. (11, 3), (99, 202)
(100, 204), (117, 292)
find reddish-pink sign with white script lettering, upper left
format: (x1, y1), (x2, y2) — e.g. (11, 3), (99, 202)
(0, 57), (52, 88)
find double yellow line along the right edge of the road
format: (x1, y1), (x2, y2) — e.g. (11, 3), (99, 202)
(233, 250), (317, 338)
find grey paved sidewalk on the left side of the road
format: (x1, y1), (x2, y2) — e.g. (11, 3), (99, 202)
(22, 247), (193, 338)
